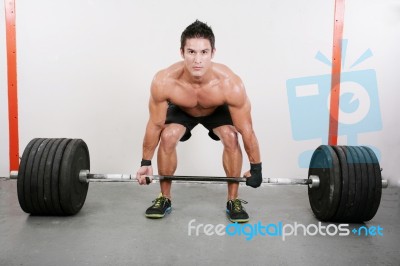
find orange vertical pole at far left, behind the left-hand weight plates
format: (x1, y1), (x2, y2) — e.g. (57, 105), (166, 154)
(4, 0), (19, 171)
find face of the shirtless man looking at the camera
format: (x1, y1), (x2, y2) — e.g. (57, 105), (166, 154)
(181, 38), (214, 77)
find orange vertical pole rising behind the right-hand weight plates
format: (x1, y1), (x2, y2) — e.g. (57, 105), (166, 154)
(328, 0), (344, 145)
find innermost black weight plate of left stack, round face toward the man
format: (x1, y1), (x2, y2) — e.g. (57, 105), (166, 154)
(59, 139), (90, 215)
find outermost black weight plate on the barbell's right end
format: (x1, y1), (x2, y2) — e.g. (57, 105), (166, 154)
(363, 146), (382, 221)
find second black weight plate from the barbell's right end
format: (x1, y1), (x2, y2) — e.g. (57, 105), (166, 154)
(352, 146), (369, 222)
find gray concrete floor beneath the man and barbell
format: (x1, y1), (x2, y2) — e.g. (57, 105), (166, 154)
(0, 179), (400, 266)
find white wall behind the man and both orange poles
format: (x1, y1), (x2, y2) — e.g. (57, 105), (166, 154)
(0, 0), (400, 187)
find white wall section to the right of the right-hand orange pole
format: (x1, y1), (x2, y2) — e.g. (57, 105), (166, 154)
(344, 0), (400, 185)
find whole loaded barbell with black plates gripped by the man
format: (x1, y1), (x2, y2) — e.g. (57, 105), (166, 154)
(10, 138), (388, 222)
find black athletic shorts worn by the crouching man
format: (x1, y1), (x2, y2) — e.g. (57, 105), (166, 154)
(165, 103), (233, 141)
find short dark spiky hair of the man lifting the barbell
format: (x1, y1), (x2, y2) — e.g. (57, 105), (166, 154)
(181, 20), (215, 50)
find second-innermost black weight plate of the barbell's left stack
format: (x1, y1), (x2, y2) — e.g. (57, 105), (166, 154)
(51, 139), (71, 215)
